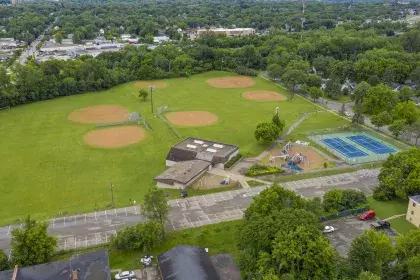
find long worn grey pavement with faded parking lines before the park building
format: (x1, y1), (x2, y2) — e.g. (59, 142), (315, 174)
(0, 169), (379, 252)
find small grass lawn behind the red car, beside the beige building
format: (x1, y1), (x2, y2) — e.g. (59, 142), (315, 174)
(368, 196), (408, 219)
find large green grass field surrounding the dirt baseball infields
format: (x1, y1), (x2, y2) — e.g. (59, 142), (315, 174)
(0, 72), (322, 225)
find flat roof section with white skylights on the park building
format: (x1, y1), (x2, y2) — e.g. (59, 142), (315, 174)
(173, 137), (238, 157)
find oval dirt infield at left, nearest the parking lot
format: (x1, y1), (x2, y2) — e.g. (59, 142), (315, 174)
(83, 126), (146, 148)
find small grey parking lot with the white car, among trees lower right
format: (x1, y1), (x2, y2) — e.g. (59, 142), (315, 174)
(324, 216), (398, 257)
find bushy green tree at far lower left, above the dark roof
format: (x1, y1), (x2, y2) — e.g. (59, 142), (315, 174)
(11, 216), (57, 266)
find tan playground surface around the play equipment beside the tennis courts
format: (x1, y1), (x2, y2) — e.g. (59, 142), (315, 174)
(263, 145), (328, 170)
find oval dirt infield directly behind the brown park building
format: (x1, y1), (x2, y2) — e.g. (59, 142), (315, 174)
(165, 111), (218, 126)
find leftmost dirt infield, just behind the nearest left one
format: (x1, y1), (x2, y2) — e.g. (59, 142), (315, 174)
(68, 105), (129, 123)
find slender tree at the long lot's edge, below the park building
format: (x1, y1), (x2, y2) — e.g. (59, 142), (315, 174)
(141, 186), (171, 225)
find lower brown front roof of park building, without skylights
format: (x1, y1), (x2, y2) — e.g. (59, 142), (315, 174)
(155, 160), (211, 185)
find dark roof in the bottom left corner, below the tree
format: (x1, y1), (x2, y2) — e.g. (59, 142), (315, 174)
(0, 251), (111, 280)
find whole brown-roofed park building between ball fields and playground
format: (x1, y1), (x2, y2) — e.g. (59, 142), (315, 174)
(155, 137), (239, 189)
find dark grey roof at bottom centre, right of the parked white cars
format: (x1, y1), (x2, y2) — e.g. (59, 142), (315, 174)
(158, 245), (220, 280)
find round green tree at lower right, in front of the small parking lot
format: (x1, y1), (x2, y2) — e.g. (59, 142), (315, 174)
(348, 230), (395, 277)
